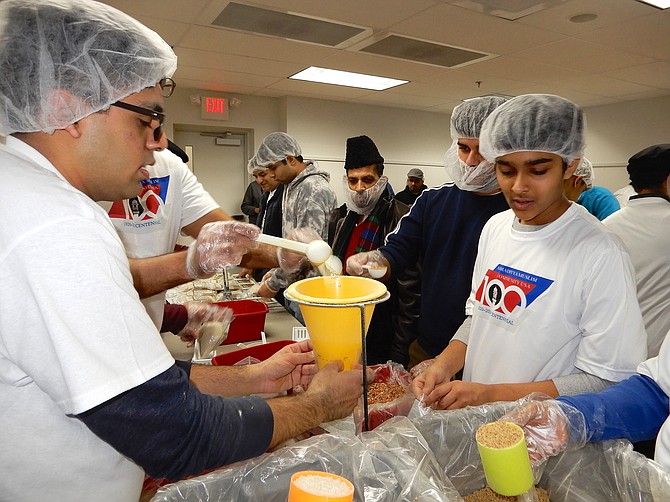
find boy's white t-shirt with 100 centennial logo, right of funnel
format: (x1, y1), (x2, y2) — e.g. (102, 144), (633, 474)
(463, 203), (647, 383)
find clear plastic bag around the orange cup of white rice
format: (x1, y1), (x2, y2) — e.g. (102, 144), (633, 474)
(151, 417), (462, 502)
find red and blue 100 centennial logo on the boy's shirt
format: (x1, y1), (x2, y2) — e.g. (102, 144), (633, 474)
(475, 265), (554, 324)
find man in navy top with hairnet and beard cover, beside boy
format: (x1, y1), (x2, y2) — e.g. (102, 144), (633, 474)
(346, 96), (509, 368)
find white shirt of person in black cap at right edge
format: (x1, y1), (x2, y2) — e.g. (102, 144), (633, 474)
(603, 197), (670, 357)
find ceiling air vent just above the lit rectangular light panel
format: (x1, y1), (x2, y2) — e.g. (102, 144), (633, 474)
(360, 35), (491, 68)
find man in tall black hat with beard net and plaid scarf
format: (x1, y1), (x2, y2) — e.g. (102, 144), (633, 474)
(332, 136), (411, 365)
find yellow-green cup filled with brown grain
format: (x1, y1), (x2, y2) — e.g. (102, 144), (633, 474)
(476, 422), (534, 497)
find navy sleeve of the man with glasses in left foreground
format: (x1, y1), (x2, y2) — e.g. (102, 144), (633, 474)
(78, 366), (274, 481)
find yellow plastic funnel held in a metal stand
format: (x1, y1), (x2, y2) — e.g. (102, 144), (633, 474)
(284, 275), (388, 370)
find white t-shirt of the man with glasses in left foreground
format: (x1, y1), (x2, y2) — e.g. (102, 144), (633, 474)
(0, 137), (174, 501)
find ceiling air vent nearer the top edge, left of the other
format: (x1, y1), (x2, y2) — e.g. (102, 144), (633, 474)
(212, 2), (364, 47)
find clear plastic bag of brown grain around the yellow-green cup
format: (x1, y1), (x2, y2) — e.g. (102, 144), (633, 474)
(409, 402), (670, 502)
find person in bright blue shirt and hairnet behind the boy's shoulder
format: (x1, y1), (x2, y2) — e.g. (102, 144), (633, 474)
(564, 158), (621, 221)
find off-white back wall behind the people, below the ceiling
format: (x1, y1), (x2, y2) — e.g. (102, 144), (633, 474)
(166, 87), (670, 203)
